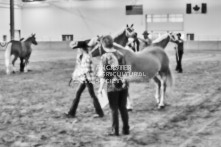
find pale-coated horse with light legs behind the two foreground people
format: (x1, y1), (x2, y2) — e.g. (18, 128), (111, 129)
(93, 37), (173, 109)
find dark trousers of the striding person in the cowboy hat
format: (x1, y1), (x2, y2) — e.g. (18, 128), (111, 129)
(68, 81), (104, 117)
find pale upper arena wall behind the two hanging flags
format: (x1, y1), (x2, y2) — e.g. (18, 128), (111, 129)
(0, 0), (221, 41)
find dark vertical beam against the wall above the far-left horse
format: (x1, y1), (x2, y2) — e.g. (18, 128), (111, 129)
(10, 0), (15, 40)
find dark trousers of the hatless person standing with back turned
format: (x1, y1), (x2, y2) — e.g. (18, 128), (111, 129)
(107, 89), (129, 134)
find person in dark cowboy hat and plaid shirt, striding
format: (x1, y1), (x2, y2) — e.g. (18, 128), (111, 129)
(66, 41), (104, 118)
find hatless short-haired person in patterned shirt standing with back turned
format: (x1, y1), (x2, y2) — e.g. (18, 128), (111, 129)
(98, 35), (130, 136)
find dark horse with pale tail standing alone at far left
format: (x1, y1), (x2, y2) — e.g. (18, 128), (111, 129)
(5, 34), (38, 74)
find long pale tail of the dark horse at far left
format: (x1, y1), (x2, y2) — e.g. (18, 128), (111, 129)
(5, 42), (12, 74)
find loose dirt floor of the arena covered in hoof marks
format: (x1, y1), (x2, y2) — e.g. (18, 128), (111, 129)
(0, 49), (221, 147)
